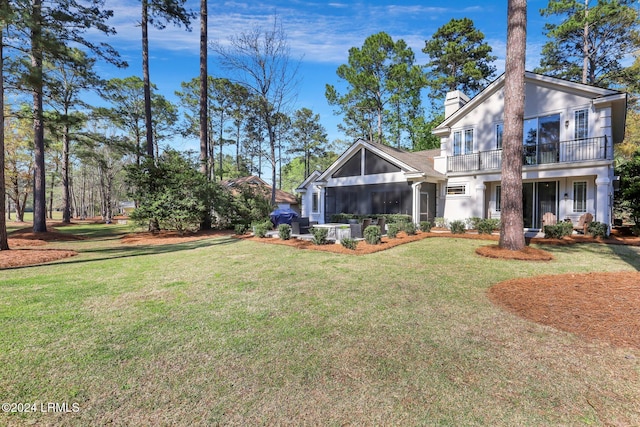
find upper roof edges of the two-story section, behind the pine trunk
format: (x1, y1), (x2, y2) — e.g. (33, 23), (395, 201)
(432, 71), (627, 143)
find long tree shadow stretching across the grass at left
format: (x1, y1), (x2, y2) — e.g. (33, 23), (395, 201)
(3, 236), (241, 270)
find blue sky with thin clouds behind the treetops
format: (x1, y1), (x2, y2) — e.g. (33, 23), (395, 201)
(89, 0), (547, 155)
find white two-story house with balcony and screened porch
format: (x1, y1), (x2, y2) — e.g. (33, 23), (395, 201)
(298, 72), (627, 229)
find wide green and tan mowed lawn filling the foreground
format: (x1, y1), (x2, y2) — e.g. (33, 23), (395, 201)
(0, 225), (640, 426)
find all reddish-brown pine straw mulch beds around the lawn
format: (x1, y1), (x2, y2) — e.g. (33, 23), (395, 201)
(0, 227), (640, 348)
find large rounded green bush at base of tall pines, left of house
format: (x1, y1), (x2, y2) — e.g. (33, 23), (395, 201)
(126, 150), (216, 234)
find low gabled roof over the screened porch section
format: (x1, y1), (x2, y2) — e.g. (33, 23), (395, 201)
(318, 139), (445, 182)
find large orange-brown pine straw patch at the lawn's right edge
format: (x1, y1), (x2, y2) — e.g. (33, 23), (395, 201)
(488, 272), (640, 348)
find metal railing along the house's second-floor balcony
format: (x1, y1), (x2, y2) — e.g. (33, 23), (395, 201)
(447, 136), (613, 172)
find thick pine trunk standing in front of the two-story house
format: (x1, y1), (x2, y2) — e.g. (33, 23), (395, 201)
(499, 0), (527, 251)
